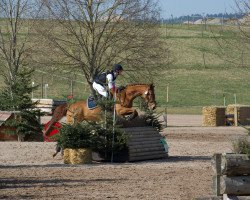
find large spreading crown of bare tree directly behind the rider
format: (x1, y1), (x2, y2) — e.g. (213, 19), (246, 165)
(39, 0), (168, 92)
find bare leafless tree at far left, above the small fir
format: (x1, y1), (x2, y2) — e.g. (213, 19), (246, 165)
(0, 0), (39, 95)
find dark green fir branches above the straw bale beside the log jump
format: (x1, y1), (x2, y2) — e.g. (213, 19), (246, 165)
(54, 121), (128, 161)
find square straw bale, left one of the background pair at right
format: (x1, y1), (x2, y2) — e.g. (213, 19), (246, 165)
(202, 106), (226, 126)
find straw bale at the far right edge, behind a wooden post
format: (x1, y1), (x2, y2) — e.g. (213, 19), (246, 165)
(226, 104), (250, 125)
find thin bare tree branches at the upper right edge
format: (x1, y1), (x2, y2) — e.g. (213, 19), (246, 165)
(207, 0), (250, 67)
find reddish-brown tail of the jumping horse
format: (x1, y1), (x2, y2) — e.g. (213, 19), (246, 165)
(43, 103), (68, 136)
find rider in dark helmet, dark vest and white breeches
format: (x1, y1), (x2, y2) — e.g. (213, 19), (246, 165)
(93, 64), (123, 98)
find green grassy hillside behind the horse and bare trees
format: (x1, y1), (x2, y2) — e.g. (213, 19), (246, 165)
(0, 22), (250, 114)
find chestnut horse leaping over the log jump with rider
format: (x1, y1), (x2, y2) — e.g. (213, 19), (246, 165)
(44, 84), (156, 135)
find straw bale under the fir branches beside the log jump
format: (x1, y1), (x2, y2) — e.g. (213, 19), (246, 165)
(63, 148), (92, 164)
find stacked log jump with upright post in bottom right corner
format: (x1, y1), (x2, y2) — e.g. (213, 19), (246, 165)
(212, 154), (250, 200)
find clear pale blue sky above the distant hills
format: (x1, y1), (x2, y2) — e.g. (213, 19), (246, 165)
(159, 0), (236, 19)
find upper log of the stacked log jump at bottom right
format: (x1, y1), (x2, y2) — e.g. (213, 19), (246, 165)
(221, 154), (250, 176)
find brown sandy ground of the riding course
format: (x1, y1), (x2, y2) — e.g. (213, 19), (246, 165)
(0, 115), (247, 200)
